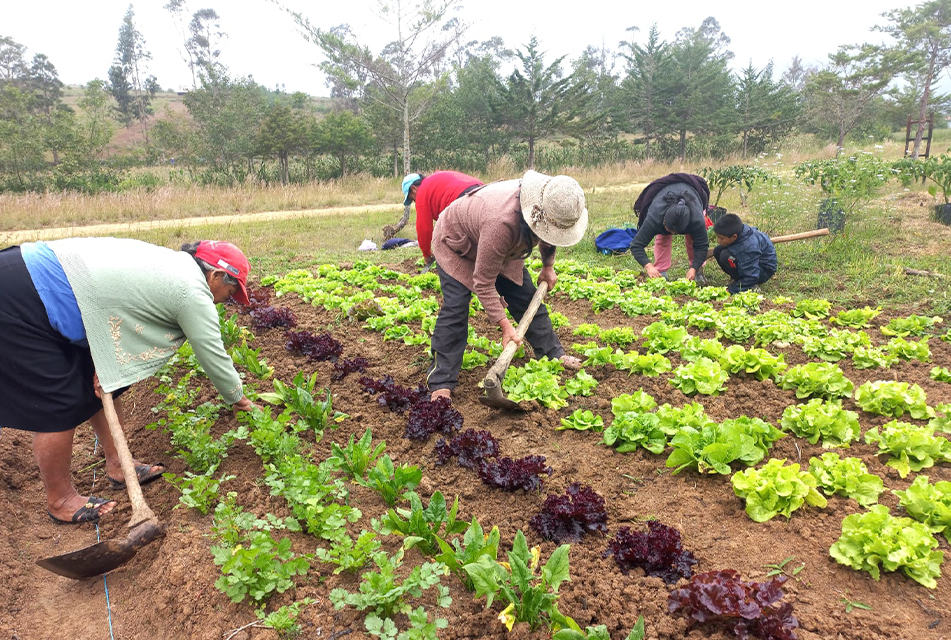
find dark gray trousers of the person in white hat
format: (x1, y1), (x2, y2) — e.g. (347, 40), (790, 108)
(426, 269), (565, 391)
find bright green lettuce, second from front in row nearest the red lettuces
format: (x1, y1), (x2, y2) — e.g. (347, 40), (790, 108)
(731, 458), (827, 522)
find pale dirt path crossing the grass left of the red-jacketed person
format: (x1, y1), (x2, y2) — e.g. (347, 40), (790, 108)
(0, 204), (399, 245)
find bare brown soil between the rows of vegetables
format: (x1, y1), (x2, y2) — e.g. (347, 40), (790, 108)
(0, 276), (951, 640)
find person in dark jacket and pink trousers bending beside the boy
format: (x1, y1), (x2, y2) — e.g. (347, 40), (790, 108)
(631, 173), (710, 280)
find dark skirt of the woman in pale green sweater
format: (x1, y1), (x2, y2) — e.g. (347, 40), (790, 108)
(0, 247), (118, 433)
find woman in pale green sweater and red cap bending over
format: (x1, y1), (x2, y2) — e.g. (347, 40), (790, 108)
(0, 238), (253, 524)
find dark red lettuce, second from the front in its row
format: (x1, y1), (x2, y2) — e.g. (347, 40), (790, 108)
(603, 520), (697, 584)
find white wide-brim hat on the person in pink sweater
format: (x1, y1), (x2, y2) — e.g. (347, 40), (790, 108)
(519, 170), (588, 247)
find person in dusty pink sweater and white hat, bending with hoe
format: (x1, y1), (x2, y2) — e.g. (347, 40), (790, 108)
(424, 171), (588, 398)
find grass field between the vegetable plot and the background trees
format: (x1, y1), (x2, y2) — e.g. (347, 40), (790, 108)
(0, 141), (951, 314)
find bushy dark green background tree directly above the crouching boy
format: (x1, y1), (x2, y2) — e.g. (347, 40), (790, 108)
(736, 61), (800, 157)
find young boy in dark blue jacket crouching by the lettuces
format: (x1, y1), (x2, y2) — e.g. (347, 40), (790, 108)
(713, 213), (777, 293)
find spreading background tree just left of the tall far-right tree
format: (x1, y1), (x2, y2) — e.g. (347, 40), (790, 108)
(803, 44), (901, 149)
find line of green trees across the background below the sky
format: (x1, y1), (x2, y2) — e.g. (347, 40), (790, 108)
(0, 0), (951, 191)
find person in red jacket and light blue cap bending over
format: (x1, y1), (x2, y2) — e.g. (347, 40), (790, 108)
(403, 171), (483, 266)
